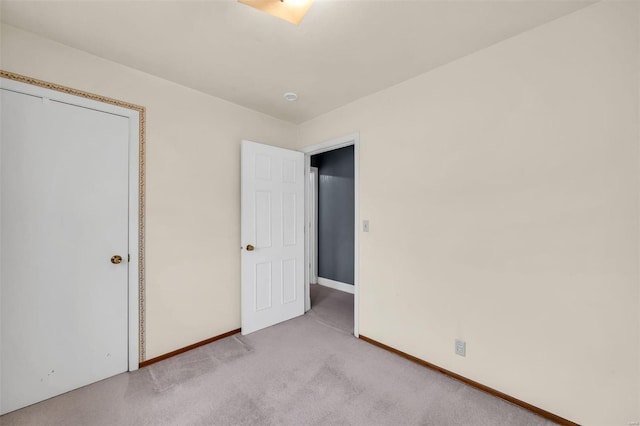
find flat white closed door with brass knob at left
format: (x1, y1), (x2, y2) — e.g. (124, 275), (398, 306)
(0, 89), (129, 413)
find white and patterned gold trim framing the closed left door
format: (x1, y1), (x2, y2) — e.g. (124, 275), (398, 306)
(0, 69), (146, 371)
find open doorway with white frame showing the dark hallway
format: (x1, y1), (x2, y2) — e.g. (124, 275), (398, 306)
(304, 135), (359, 336)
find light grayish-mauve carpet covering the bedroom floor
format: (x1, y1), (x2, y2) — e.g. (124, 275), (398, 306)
(0, 288), (552, 426)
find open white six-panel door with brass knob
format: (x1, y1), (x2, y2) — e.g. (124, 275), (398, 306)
(241, 141), (305, 334)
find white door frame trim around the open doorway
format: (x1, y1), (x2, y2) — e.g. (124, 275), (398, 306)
(300, 133), (360, 337)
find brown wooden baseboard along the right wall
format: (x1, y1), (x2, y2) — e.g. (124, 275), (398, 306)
(359, 334), (580, 426)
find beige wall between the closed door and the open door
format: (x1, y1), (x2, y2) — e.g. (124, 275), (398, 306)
(1, 25), (297, 358)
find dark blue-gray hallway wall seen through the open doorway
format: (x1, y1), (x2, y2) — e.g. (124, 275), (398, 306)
(311, 146), (355, 284)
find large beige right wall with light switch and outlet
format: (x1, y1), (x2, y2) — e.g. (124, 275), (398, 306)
(299, 2), (640, 426)
